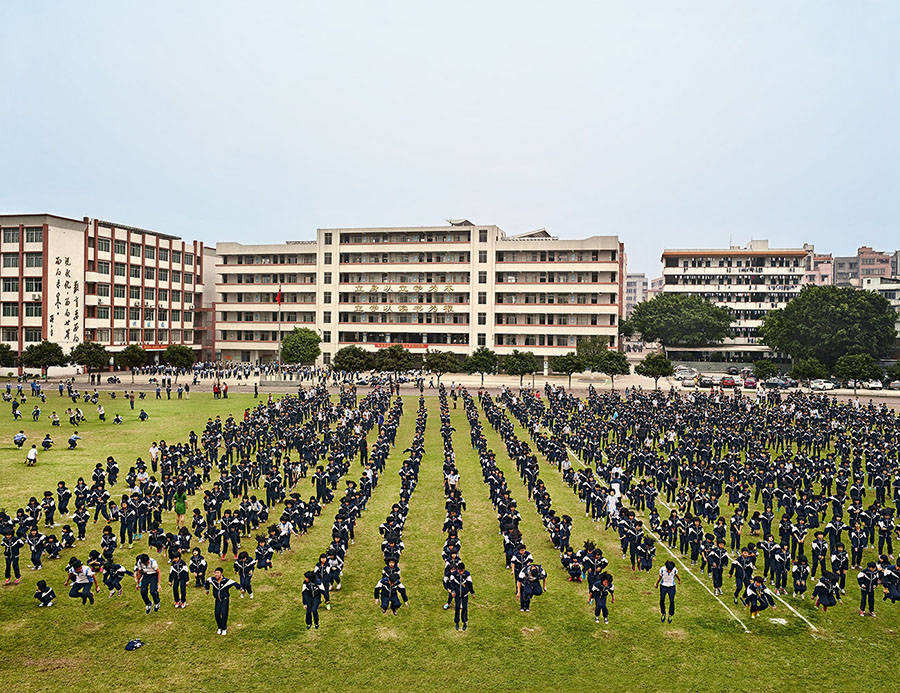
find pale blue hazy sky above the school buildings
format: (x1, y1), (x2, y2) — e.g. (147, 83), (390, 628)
(0, 0), (900, 276)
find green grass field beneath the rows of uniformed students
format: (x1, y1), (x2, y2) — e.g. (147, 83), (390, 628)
(0, 393), (900, 691)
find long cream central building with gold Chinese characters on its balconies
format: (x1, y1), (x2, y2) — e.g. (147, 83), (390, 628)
(215, 219), (624, 363)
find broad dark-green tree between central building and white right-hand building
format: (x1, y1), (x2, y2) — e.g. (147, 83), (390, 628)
(626, 293), (731, 353)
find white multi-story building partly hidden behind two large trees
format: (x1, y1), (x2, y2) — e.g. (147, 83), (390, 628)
(662, 240), (813, 359)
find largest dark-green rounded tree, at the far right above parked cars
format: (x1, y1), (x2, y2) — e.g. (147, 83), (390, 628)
(759, 286), (897, 368)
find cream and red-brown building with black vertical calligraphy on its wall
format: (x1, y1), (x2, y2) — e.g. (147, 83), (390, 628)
(0, 214), (209, 360)
